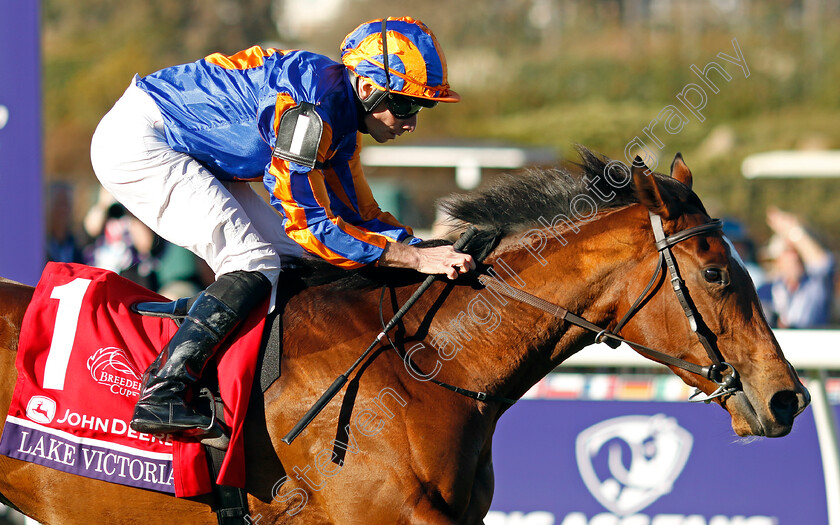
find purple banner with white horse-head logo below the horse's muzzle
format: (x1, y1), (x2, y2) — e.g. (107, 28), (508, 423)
(485, 400), (828, 525)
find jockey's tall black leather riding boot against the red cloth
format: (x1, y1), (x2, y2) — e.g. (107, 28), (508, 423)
(131, 271), (271, 438)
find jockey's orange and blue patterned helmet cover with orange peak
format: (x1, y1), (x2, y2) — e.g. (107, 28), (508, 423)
(341, 17), (461, 109)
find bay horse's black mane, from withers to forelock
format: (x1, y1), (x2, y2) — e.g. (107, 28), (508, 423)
(297, 146), (703, 290)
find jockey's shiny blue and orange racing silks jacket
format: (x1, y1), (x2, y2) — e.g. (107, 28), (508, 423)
(137, 46), (420, 268)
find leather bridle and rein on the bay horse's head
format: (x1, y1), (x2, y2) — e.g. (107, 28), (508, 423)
(481, 213), (741, 403)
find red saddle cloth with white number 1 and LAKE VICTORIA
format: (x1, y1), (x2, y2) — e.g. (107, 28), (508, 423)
(0, 263), (268, 497)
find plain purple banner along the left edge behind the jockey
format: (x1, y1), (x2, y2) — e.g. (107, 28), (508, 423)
(0, 0), (44, 285)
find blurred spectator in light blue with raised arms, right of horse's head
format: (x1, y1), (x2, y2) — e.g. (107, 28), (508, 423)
(758, 207), (835, 328)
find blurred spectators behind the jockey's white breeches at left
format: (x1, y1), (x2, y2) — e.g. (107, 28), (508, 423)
(46, 183), (213, 299)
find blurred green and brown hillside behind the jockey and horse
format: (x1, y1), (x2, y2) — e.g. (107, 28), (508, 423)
(42, 0), (840, 223)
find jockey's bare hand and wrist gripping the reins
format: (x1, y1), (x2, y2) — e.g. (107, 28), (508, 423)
(379, 242), (475, 279)
